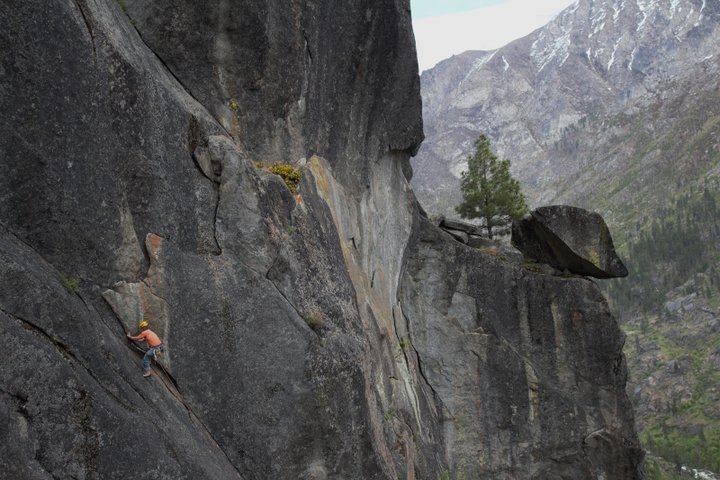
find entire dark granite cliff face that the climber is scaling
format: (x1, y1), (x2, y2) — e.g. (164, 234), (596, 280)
(0, 0), (642, 479)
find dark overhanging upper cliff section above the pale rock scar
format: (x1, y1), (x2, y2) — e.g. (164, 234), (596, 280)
(125, 0), (423, 188)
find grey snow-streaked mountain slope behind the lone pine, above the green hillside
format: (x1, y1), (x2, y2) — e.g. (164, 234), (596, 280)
(413, 0), (720, 216)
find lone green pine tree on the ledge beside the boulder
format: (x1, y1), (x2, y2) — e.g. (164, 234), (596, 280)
(455, 134), (528, 239)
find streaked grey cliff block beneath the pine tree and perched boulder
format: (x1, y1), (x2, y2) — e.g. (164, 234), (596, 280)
(401, 220), (642, 480)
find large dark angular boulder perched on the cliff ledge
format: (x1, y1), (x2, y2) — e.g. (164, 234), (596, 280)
(512, 205), (628, 278)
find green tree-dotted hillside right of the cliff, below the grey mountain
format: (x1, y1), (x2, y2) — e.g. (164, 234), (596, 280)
(607, 178), (720, 478)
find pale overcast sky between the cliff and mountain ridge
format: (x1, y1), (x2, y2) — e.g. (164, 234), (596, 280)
(410, 0), (574, 71)
